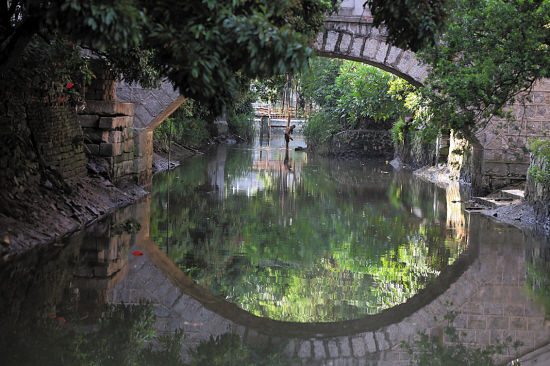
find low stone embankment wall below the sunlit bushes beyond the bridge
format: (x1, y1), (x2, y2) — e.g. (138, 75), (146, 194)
(315, 130), (393, 159)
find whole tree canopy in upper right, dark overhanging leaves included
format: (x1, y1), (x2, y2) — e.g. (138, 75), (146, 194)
(366, 0), (550, 137)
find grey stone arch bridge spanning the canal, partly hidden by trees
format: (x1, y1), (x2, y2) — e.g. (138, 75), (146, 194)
(77, 0), (550, 190)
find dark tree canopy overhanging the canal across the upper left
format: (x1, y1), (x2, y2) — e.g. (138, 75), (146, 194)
(0, 0), (337, 108)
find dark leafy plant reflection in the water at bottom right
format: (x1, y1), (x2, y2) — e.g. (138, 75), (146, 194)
(401, 312), (522, 366)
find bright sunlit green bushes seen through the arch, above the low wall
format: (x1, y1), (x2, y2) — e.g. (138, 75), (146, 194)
(301, 58), (418, 145)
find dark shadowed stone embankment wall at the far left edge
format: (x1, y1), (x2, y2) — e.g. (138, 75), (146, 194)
(0, 74), (86, 194)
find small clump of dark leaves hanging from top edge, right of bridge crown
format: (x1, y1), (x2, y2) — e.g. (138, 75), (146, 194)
(365, 0), (449, 51)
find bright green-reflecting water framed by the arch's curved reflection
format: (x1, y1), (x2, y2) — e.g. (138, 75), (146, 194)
(151, 132), (465, 322)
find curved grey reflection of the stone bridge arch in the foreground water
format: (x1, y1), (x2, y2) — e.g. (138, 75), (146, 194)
(111, 202), (550, 365)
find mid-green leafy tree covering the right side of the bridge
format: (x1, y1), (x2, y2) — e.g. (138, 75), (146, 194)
(419, 0), (550, 136)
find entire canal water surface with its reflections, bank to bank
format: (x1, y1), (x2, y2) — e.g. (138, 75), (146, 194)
(0, 130), (550, 365)
